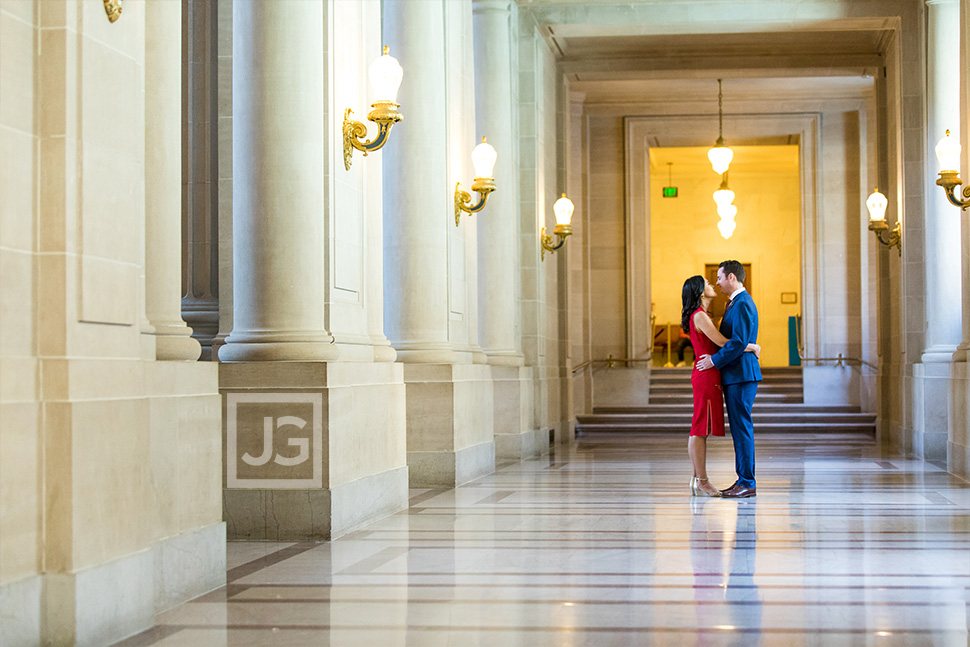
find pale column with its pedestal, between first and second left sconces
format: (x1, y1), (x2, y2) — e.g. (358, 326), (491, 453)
(380, 0), (496, 487)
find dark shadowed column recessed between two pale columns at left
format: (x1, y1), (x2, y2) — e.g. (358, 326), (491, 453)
(182, 0), (219, 360)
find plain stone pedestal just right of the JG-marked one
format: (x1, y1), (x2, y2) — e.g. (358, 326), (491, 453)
(404, 364), (495, 487)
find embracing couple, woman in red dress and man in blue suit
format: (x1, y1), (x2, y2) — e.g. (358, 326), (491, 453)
(681, 261), (761, 499)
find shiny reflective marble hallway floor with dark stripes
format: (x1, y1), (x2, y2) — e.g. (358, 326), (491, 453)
(120, 435), (970, 647)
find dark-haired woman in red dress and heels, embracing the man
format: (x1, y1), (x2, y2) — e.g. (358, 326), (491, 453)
(681, 276), (761, 497)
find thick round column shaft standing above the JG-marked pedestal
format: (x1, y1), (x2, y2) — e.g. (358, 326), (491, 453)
(219, 0), (337, 362)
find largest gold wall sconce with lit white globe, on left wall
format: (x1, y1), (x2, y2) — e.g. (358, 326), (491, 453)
(343, 45), (404, 171)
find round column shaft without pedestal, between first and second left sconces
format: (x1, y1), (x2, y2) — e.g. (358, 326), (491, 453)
(380, 0), (456, 363)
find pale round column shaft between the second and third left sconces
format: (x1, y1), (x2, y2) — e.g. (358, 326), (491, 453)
(474, 0), (523, 366)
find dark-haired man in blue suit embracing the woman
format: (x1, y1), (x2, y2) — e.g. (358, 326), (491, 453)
(697, 261), (761, 499)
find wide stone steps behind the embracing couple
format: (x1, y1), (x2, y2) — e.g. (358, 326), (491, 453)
(576, 367), (876, 437)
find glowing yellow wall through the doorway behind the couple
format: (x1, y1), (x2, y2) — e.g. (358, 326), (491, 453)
(650, 146), (802, 366)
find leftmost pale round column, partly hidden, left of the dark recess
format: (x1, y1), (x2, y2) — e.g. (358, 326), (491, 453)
(145, 2), (201, 360)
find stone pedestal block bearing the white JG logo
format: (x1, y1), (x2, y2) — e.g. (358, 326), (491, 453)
(219, 362), (408, 541)
